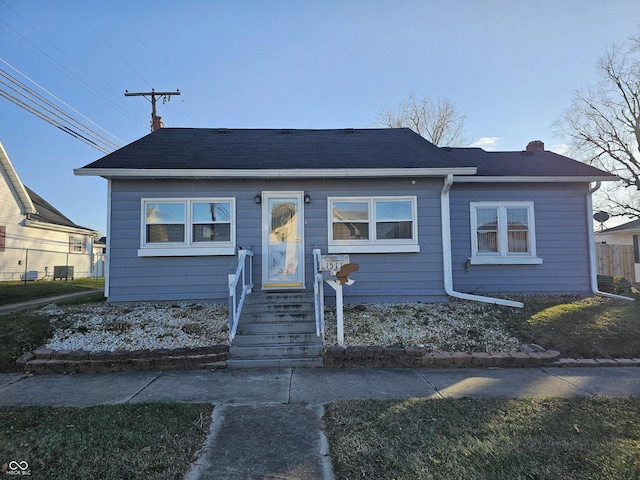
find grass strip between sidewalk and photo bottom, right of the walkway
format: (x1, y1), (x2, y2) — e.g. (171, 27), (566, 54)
(325, 398), (640, 480)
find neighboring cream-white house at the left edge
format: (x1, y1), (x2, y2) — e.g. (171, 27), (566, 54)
(0, 143), (100, 281)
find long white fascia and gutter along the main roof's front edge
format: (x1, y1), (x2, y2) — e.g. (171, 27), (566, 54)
(73, 167), (477, 178)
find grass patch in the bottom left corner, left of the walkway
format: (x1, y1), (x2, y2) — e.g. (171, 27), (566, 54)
(0, 403), (213, 480)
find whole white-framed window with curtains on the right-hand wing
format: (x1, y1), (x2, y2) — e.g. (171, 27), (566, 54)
(470, 202), (542, 265)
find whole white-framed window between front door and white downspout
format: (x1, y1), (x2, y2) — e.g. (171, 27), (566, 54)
(328, 197), (420, 253)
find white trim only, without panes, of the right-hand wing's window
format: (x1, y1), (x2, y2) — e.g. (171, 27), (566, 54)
(469, 201), (542, 265)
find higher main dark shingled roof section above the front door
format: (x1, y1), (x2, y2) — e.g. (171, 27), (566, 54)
(79, 128), (470, 169)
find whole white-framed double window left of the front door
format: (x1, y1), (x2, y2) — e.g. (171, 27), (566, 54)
(138, 198), (235, 256)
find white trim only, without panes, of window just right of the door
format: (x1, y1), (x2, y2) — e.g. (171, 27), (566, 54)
(327, 195), (420, 253)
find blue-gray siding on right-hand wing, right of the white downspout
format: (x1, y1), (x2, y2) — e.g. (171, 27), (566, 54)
(450, 183), (591, 295)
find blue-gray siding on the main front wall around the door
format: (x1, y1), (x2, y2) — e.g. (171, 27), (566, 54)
(109, 179), (446, 303)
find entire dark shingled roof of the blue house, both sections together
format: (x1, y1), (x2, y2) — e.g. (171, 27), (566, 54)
(82, 128), (615, 179)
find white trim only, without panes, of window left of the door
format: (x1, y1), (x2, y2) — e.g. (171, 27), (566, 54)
(138, 197), (236, 257)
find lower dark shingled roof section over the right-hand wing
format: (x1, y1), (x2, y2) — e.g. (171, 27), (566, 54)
(444, 148), (615, 180)
